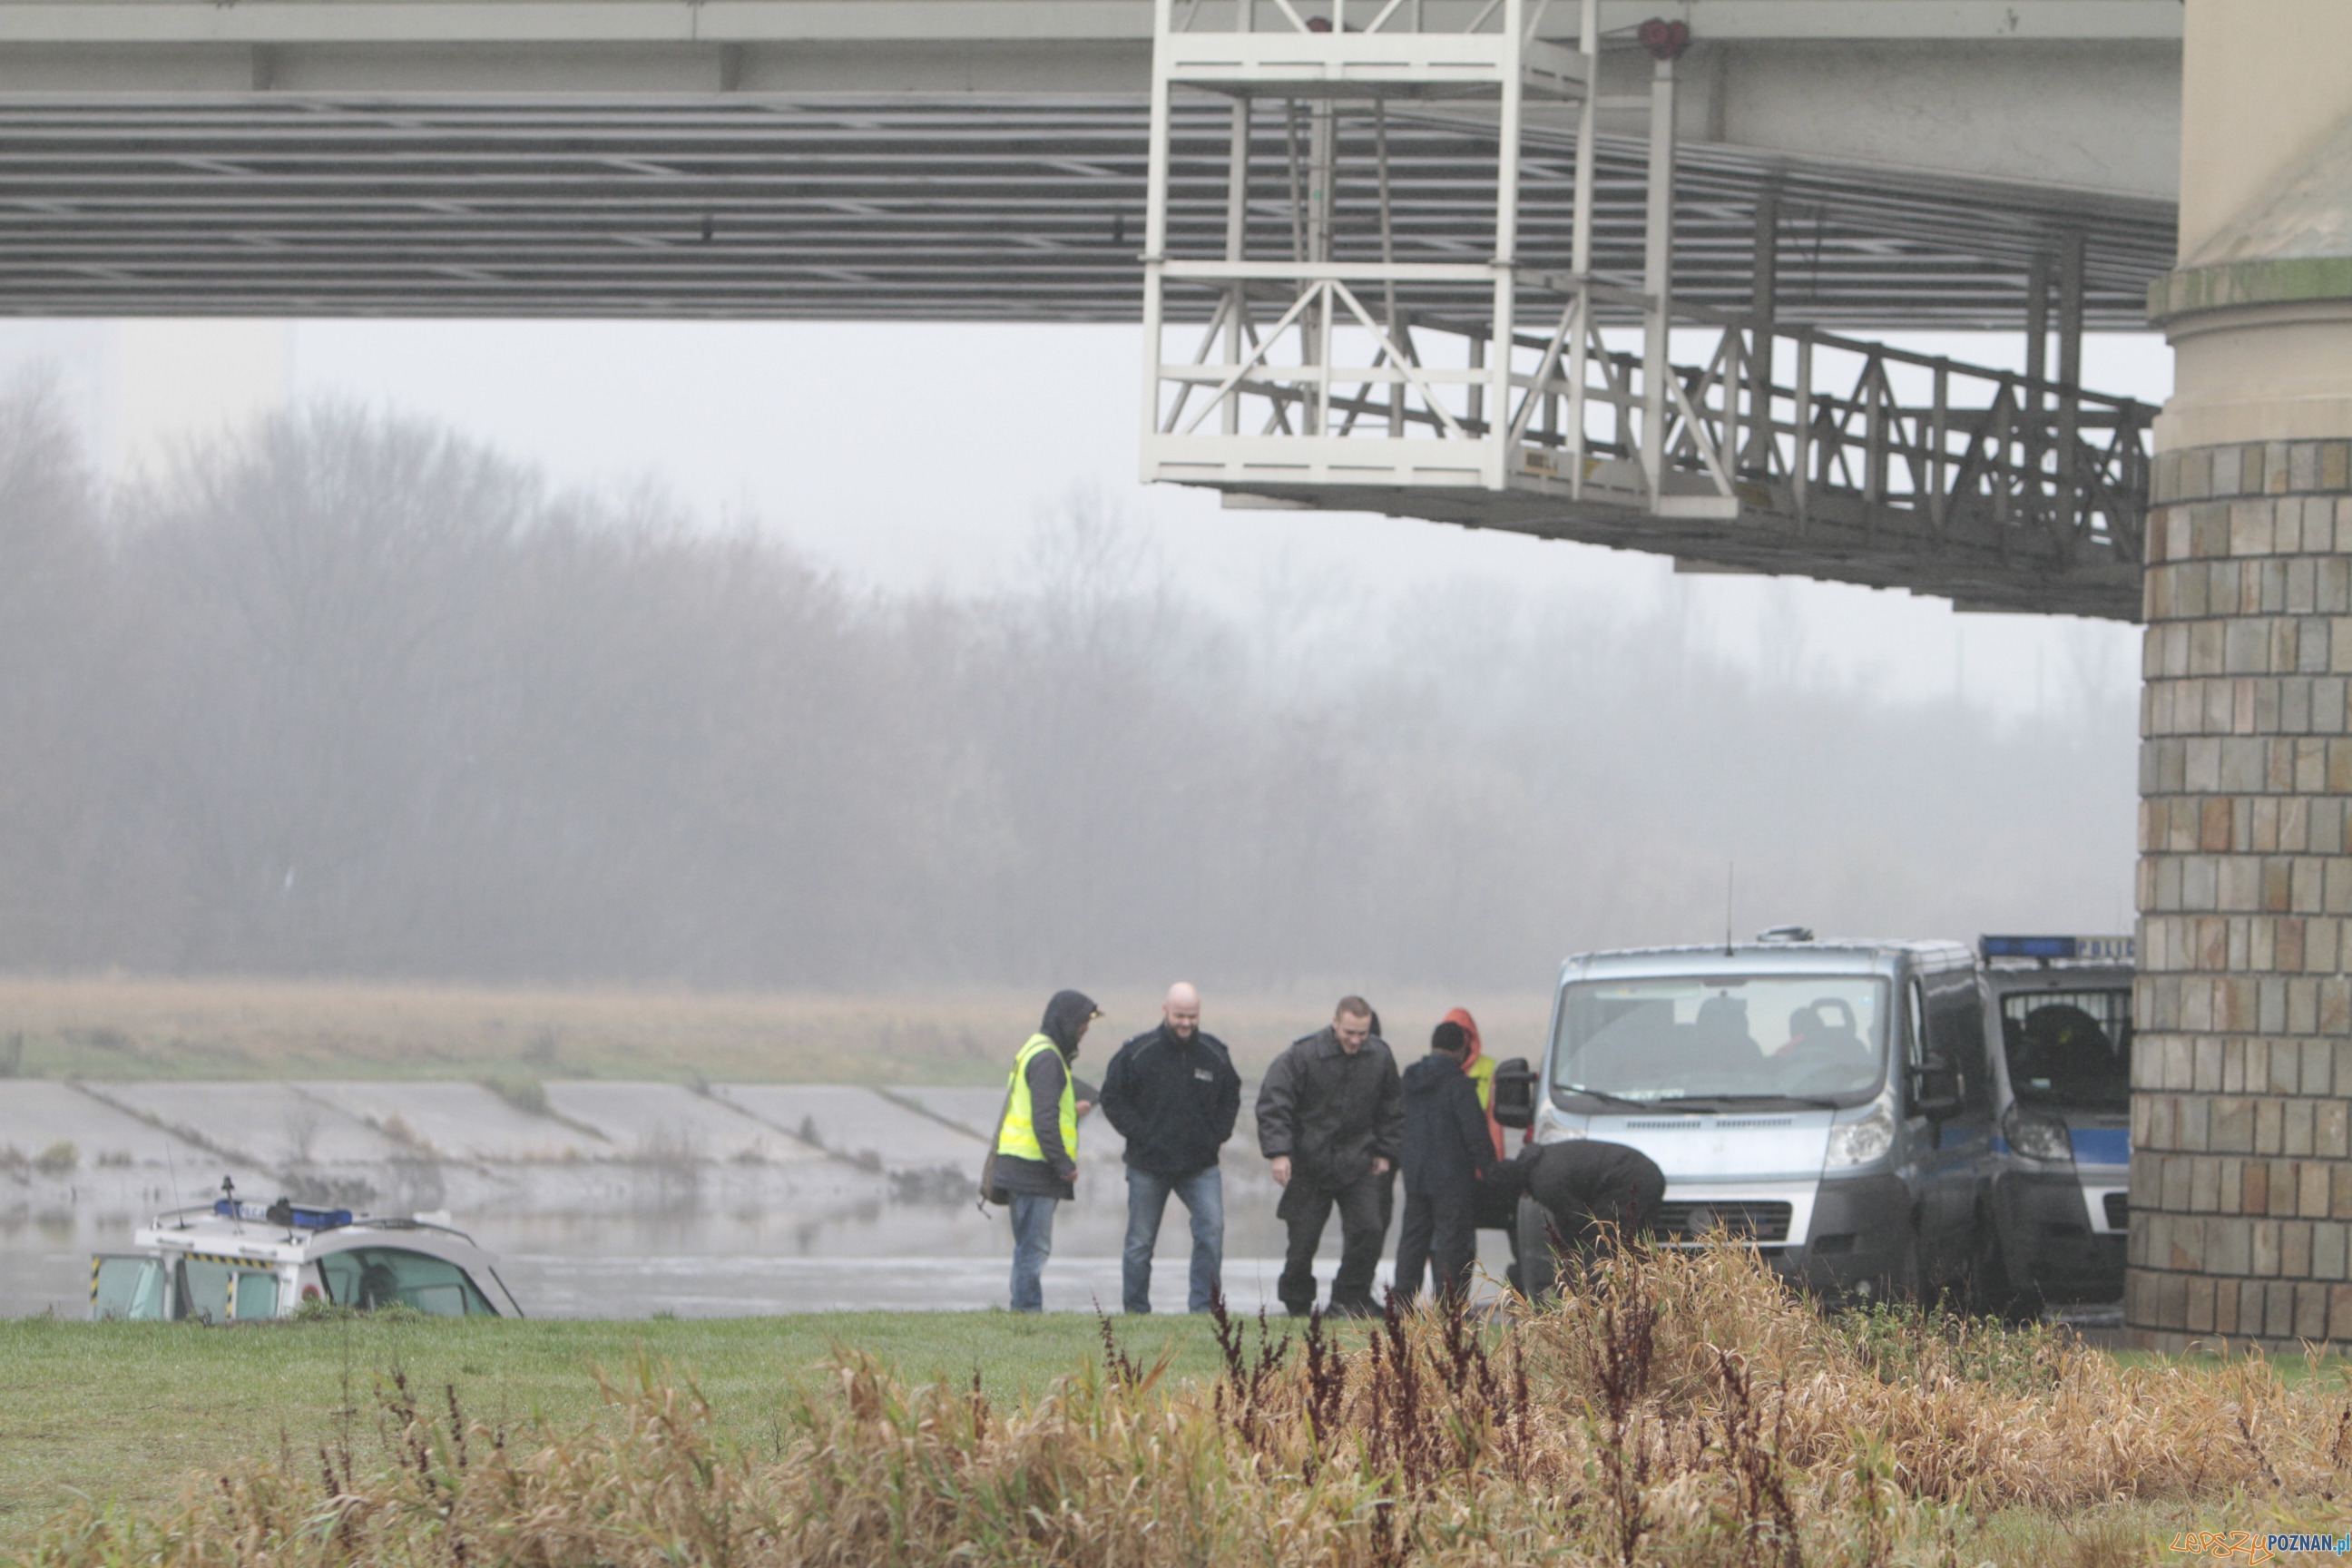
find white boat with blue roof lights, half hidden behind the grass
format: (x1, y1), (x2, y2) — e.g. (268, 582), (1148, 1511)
(89, 1178), (522, 1324)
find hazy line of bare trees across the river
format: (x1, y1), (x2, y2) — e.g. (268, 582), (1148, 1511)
(0, 387), (2133, 987)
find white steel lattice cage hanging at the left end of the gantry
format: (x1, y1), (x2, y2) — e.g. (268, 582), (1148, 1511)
(1143, 0), (1599, 494)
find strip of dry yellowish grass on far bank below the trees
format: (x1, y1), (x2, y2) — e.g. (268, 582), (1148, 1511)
(0, 975), (1548, 1083)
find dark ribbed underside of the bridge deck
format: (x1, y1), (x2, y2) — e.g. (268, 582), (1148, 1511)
(0, 89), (2176, 329)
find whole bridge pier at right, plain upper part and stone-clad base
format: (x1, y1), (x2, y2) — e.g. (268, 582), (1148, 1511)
(2124, 0), (2352, 1349)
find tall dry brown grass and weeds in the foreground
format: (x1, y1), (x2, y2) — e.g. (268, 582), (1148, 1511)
(31, 1249), (2352, 1568)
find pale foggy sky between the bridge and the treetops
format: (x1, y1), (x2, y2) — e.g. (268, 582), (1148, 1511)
(0, 319), (2171, 715)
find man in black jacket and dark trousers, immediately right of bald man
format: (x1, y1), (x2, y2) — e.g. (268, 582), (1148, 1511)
(1259, 996), (1404, 1317)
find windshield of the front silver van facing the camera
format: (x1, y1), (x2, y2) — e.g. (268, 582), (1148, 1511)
(1553, 975), (1886, 1105)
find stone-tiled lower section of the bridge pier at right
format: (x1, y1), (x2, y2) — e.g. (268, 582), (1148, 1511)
(2124, 442), (2352, 1349)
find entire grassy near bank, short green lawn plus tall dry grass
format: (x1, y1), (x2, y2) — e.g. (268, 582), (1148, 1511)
(0, 1253), (2352, 1568)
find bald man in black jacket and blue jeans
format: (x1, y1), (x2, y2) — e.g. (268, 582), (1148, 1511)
(1103, 980), (1242, 1312)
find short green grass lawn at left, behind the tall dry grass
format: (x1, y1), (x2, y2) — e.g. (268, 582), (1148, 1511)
(0, 1312), (1260, 1552)
